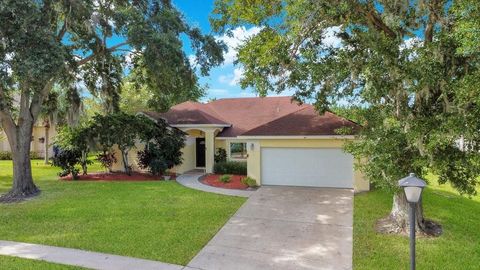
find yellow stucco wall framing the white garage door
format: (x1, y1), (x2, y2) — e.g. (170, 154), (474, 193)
(247, 139), (370, 192)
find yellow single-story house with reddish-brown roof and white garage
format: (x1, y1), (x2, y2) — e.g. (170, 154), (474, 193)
(114, 97), (369, 191)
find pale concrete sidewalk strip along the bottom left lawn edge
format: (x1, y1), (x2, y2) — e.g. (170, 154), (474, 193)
(0, 240), (193, 270)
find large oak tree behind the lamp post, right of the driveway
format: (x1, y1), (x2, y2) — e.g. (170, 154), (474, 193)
(211, 0), (480, 234)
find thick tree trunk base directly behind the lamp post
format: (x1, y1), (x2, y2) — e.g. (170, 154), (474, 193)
(377, 191), (442, 236)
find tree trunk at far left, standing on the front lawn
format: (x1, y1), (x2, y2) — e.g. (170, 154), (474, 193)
(0, 118), (40, 202)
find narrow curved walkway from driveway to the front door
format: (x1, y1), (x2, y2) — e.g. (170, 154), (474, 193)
(177, 172), (255, 198)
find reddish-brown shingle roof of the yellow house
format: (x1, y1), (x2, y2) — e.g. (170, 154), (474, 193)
(145, 97), (359, 137)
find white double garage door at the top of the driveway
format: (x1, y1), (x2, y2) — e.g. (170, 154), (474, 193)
(261, 148), (353, 188)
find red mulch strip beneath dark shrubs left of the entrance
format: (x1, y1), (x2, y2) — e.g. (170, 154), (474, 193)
(60, 172), (175, 181)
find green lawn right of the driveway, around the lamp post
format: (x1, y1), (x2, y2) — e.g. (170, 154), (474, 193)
(353, 178), (480, 270)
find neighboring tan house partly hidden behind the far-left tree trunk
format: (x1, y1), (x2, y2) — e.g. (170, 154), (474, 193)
(0, 121), (57, 157)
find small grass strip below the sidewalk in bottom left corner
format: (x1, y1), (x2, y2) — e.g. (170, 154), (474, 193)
(0, 256), (85, 270)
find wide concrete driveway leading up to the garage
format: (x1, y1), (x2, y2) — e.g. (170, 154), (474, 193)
(188, 186), (353, 270)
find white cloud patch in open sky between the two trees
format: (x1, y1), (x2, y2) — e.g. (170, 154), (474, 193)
(216, 26), (262, 64)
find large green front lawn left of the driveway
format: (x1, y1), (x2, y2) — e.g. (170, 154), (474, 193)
(0, 161), (245, 269)
